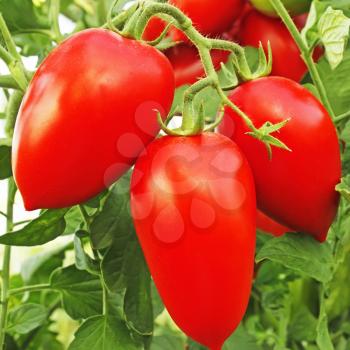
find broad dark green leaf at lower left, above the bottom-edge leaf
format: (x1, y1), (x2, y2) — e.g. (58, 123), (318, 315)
(50, 265), (102, 319)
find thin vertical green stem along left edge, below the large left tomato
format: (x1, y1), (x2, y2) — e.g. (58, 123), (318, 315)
(0, 178), (16, 349)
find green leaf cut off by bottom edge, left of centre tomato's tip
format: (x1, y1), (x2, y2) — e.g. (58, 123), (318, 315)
(68, 315), (142, 350)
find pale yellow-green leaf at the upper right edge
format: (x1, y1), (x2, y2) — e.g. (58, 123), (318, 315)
(318, 7), (350, 69)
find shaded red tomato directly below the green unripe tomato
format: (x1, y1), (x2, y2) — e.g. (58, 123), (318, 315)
(238, 10), (314, 81)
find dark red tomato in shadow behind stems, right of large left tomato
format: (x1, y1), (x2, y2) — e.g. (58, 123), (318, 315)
(165, 44), (229, 87)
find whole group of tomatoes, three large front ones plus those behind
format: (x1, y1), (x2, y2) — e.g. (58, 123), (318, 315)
(13, 0), (341, 350)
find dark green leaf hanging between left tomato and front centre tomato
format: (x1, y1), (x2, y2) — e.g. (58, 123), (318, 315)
(90, 176), (132, 249)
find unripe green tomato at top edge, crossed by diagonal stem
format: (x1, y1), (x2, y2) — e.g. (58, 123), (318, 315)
(250, 0), (311, 17)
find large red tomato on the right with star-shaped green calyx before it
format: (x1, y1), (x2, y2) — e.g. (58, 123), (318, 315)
(220, 77), (341, 241)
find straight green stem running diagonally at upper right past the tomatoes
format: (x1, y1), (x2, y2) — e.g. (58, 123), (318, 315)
(270, 0), (335, 119)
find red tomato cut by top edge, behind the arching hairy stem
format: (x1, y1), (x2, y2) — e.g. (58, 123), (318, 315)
(143, 0), (244, 41)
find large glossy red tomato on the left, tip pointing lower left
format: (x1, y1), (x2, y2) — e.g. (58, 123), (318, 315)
(13, 29), (174, 210)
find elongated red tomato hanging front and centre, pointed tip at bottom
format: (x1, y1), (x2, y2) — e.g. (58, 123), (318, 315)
(131, 133), (256, 350)
